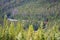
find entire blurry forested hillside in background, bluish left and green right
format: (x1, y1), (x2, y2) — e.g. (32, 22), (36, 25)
(0, 0), (60, 20)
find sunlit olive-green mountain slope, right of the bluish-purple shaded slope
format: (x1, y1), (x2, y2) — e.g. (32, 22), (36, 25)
(14, 0), (60, 19)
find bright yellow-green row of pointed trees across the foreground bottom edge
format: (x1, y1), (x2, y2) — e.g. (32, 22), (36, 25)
(0, 18), (60, 40)
